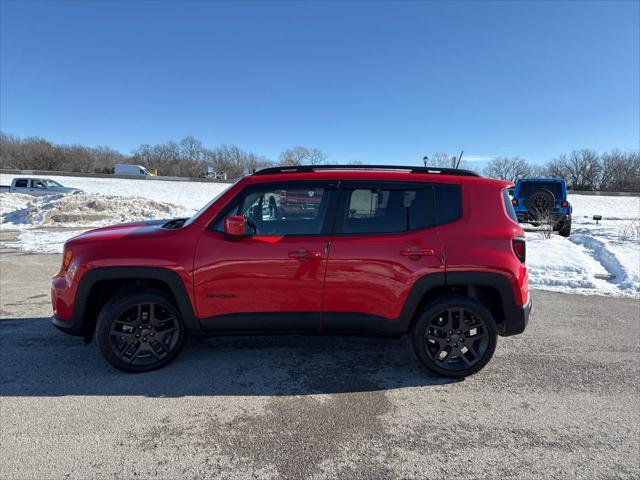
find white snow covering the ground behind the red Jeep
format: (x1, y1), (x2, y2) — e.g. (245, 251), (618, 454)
(0, 174), (640, 297)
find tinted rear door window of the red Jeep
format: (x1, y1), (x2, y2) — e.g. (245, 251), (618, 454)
(340, 187), (435, 234)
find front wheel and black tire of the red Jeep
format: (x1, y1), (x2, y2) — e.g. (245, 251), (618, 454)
(96, 291), (186, 373)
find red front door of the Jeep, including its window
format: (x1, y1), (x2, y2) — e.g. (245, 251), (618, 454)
(194, 182), (337, 332)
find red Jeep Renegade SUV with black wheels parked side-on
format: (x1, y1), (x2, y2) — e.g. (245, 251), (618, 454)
(51, 166), (531, 377)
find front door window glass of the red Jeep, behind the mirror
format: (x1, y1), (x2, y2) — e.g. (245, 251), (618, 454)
(213, 184), (329, 236)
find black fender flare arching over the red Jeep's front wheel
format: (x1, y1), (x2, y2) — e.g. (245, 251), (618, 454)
(64, 267), (202, 336)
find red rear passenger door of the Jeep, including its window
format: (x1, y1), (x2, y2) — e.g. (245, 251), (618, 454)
(323, 182), (444, 332)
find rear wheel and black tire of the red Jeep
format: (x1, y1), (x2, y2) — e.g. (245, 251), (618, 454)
(412, 295), (498, 377)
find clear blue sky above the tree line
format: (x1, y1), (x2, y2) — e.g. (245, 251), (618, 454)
(0, 0), (640, 163)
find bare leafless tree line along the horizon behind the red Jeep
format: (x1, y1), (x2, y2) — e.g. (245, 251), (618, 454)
(0, 132), (640, 191)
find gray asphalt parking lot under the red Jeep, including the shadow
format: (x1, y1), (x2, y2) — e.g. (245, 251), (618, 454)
(0, 249), (640, 479)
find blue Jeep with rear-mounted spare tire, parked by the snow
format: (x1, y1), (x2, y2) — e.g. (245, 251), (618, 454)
(511, 178), (573, 237)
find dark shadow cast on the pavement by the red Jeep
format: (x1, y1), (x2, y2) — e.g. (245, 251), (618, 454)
(0, 318), (456, 397)
